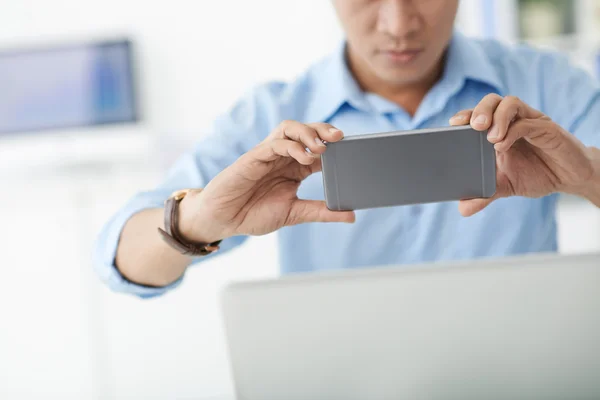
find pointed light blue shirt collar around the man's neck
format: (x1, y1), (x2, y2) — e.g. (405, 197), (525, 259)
(306, 32), (504, 122)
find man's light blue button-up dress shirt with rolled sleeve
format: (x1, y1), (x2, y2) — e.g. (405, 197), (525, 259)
(94, 33), (600, 297)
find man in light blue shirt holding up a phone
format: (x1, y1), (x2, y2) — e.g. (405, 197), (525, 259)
(95, 0), (600, 297)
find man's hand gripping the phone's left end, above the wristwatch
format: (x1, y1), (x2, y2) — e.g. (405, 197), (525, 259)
(179, 121), (355, 243)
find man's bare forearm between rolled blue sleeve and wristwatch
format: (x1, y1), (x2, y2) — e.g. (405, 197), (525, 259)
(115, 208), (192, 287)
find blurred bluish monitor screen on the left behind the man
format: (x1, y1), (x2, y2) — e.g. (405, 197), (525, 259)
(0, 40), (137, 134)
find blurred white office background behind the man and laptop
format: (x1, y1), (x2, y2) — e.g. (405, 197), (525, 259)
(0, 0), (600, 399)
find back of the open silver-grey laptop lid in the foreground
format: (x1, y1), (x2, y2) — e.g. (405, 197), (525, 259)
(222, 254), (600, 400)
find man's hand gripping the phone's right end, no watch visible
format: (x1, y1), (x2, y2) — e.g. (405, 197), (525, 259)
(450, 94), (594, 216)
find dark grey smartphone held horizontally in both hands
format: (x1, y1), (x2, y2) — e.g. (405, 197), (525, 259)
(321, 125), (496, 211)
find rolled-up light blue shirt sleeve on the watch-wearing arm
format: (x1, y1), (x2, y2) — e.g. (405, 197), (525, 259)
(92, 85), (284, 298)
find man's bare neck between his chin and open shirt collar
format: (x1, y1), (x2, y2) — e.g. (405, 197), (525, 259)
(346, 47), (445, 116)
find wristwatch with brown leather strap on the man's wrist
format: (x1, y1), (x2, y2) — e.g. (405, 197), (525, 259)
(158, 189), (221, 256)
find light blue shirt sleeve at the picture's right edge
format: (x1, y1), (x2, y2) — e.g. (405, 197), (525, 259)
(539, 50), (600, 147)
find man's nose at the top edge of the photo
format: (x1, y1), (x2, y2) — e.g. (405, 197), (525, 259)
(377, 0), (420, 38)
